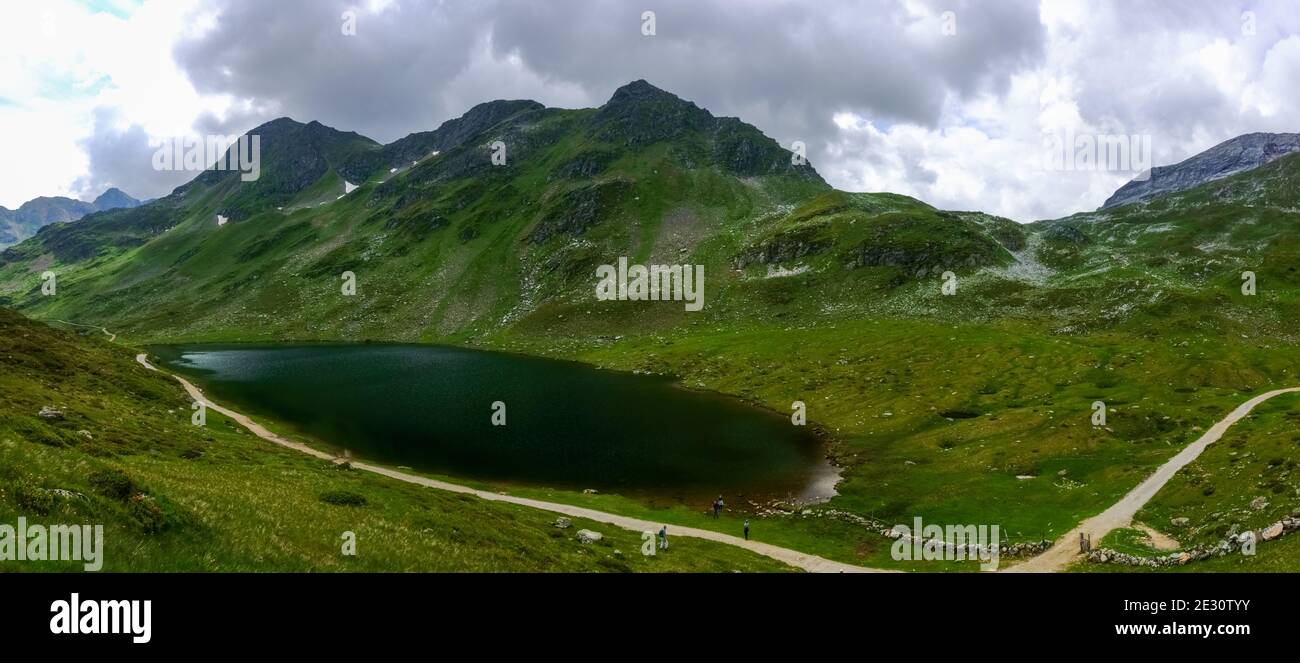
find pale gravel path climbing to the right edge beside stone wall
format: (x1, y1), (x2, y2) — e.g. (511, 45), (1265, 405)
(1006, 387), (1300, 573)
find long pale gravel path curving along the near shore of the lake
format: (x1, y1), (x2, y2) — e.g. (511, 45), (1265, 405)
(135, 354), (889, 573)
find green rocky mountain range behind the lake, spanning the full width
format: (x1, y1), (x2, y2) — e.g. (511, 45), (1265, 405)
(0, 81), (1300, 341)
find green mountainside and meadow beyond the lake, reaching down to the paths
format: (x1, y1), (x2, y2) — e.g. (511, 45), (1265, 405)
(0, 82), (1300, 566)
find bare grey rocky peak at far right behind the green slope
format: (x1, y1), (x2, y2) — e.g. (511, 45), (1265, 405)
(1101, 134), (1300, 209)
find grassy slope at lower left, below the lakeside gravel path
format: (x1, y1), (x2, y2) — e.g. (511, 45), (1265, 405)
(0, 309), (788, 572)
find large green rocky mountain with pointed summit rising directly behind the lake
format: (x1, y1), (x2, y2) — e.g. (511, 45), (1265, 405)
(0, 83), (1023, 341)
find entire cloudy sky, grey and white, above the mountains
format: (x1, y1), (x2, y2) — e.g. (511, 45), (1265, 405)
(0, 0), (1300, 221)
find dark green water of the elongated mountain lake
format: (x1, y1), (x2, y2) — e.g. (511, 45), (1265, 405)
(150, 345), (835, 503)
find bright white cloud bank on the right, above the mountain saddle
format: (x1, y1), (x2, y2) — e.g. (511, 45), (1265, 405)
(815, 0), (1300, 221)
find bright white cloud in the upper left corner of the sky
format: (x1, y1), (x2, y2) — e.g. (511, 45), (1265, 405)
(0, 0), (229, 208)
